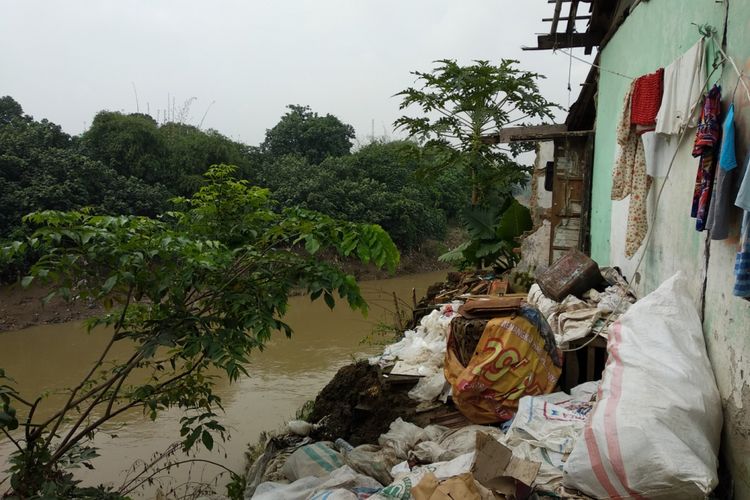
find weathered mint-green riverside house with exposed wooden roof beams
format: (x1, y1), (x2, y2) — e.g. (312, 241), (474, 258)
(520, 0), (750, 498)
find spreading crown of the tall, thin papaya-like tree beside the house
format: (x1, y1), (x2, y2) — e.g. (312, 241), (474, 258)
(395, 59), (555, 206)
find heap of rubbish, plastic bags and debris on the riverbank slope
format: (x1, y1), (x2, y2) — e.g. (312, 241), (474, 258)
(245, 258), (720, 500)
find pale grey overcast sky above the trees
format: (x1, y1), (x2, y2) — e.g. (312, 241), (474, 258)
(0, 0), (589, 145)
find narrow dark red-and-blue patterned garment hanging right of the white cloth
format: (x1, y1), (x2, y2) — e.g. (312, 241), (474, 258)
(690, 85), (721, 231)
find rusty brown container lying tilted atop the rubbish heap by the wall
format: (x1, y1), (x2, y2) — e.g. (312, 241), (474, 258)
(536, 250), (603, 302)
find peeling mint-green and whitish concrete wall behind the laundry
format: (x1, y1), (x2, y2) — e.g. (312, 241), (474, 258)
(591, 0), (750, 498)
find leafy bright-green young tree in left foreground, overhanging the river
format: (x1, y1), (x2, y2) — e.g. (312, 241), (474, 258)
(0, 165), (398, 498)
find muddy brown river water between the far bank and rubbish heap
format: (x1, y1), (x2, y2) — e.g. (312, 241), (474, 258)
(0, 271), (445, 498)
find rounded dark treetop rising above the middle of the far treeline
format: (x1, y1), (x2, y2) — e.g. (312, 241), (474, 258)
(261, 104), (354, 165)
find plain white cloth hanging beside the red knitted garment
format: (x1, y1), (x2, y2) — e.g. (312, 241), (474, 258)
(656, 38), (706, 135)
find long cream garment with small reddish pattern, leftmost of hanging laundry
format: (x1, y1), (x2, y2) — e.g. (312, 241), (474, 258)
(612, 82), (651, 258)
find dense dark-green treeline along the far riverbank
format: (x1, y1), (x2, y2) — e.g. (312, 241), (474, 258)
(0, 96), (468, 258)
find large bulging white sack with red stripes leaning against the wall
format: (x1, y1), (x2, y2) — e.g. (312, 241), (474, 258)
(564, 273), (722, 499)
